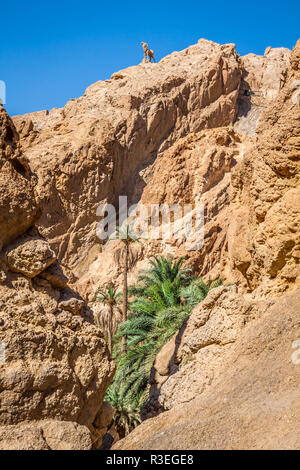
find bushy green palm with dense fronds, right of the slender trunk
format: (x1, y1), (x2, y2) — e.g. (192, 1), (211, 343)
(108, 256), (223, 422)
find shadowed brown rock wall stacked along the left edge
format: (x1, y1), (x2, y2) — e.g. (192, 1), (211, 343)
(0, 104), (114, 449)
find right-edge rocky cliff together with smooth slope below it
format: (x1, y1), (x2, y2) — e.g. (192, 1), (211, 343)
(114, 42), (300, 449)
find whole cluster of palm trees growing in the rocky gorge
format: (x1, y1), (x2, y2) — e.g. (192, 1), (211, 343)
(97, 227), (221, 436)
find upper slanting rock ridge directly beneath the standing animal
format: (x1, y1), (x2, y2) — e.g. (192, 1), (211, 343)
(14, 39), (288, 286)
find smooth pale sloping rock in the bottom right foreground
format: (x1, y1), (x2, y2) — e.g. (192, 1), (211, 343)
(113, 287), (300, 450)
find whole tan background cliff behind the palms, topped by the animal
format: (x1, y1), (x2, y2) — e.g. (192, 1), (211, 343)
(14, 39), (290, 298)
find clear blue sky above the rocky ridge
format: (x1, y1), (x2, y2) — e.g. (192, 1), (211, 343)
(0, 0), (300, 115)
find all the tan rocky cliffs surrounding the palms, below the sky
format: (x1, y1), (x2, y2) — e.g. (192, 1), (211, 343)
(0, 39), (300, 449)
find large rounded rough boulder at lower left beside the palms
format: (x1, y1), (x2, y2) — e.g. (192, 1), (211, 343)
(0, 266), (114, 429)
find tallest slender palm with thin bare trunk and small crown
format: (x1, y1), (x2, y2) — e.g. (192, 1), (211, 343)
(116, 225), (139, 354)
